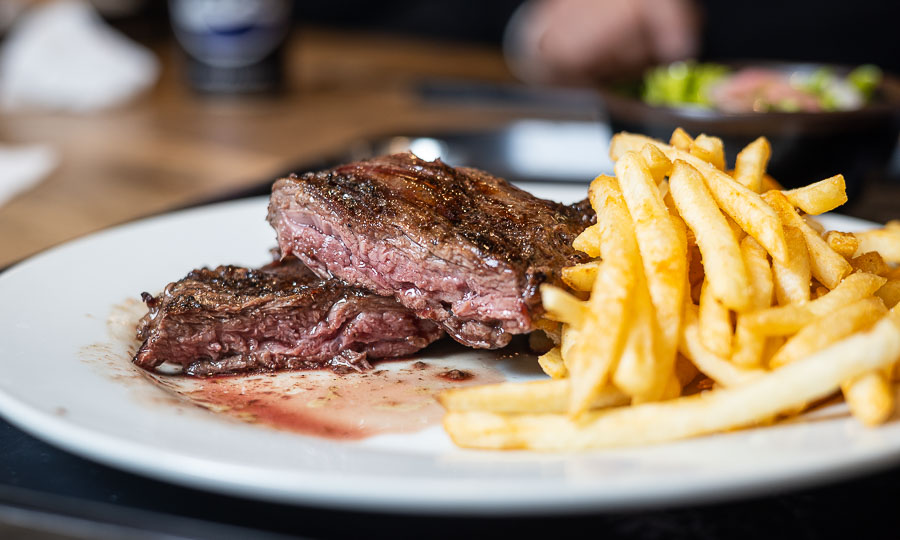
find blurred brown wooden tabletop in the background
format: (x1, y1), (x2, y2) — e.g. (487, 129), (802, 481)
(0, 29), (536, 267)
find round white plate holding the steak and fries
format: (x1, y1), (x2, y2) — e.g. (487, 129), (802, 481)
(0, 185), (900, 515)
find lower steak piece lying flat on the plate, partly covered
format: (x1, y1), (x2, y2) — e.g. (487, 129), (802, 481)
(134, 259), (443, 376)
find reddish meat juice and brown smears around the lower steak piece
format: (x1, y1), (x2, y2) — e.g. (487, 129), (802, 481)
(97, 302), (510, 440)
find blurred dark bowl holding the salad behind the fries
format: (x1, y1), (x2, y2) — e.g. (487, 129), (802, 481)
(600, 61), (900, 196)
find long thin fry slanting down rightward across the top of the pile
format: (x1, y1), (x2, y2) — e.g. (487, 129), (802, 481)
(610, 132), (788, 263)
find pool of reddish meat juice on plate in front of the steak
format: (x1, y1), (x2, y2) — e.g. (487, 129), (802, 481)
(152, 359), (504, 440)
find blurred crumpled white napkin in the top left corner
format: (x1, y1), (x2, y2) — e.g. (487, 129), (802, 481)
(0, 0), (159, 112)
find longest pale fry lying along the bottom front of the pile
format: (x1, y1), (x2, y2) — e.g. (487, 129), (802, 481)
(444, 317), (900, 451)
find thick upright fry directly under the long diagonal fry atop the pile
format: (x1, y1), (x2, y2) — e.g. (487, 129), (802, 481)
(669, 160), (750, 310)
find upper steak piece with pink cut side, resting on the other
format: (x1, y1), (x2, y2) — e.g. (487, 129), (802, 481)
(269, 153), (594, 348)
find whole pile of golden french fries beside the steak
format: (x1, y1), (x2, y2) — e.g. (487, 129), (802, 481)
(439, 129), (900, 450)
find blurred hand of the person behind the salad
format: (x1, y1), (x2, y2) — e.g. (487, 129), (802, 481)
(504, 0), (700, 84)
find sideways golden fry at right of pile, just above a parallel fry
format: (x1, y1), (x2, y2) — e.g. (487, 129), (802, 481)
(738, 272), (887, 336)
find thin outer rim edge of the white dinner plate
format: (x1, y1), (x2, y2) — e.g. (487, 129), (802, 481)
(0, 194), (900, 516)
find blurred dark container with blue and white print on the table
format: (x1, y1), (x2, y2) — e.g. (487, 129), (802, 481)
(169, 0), (291, 94)
